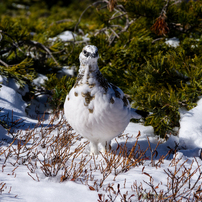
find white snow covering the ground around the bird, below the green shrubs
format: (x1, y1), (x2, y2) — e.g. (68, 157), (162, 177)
(0, 75), (202, 202)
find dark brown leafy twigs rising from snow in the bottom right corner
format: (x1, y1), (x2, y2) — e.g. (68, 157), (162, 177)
(98, 157), (202, 202)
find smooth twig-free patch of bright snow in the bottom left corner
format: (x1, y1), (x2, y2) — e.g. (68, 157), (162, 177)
(0, 173), (97, 202)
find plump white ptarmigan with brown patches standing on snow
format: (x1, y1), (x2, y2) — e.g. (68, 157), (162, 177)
(64, 45), (147, 154)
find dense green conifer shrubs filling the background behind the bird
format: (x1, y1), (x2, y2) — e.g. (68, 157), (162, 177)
(0, 0), (202, 137)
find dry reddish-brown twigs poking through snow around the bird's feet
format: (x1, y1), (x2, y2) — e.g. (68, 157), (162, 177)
(0, 113), (202, 202)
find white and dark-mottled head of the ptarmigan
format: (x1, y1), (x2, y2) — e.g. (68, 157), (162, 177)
(79, 45), (99, 66)
